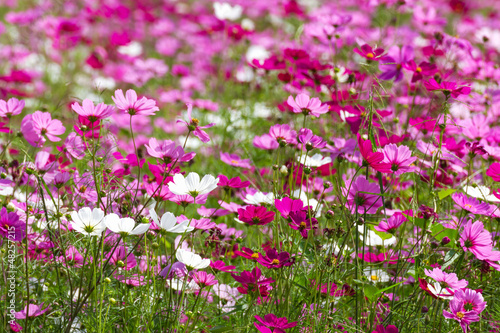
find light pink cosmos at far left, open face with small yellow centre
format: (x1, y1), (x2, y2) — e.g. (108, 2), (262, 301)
(21, 111), (66, 147)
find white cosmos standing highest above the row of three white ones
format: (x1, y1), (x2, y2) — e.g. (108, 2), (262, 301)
(168, 172), (219, 198)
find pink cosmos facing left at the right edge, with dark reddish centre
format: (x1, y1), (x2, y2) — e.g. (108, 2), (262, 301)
(460, 221), (493, 260)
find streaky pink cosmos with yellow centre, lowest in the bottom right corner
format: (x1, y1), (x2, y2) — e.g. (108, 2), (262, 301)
(443, 289), (486, 333)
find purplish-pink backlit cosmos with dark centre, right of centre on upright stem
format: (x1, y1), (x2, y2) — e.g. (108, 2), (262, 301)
(342, 176), (382, 214)
